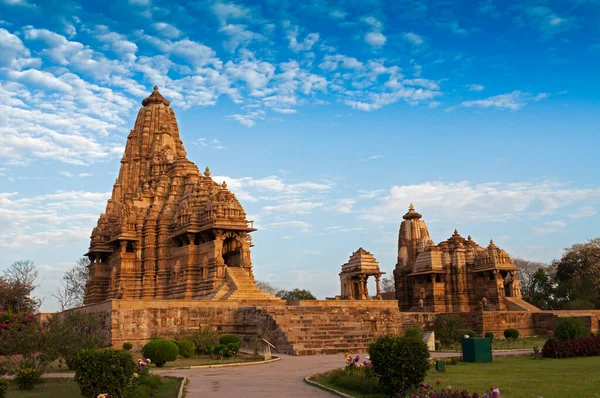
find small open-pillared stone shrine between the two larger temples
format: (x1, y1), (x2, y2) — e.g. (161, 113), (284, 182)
(340, 247), (385, 300)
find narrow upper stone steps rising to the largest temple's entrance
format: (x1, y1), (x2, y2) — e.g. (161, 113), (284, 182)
(221, 267), (283, 302)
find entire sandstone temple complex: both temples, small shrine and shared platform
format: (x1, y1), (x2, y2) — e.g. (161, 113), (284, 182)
(77, 87), (600, 355)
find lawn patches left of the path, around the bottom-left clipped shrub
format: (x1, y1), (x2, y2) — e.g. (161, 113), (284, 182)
(6, 377), (182, 398)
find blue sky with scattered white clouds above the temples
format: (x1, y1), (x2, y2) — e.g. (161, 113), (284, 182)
(0, 0), (600, 311)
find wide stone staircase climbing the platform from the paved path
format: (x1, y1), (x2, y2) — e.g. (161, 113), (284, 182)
(257, 306), (375, 355)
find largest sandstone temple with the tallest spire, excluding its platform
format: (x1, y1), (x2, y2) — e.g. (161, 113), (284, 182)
(85, 86), (276, 304)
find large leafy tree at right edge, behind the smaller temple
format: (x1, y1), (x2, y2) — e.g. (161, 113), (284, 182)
(552, 238), (600, 309)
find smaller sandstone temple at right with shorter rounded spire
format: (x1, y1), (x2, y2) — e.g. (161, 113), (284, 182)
(394, 204), (528, 312)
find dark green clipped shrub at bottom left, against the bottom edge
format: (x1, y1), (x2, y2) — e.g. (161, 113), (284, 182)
(73, 348), (135, 398)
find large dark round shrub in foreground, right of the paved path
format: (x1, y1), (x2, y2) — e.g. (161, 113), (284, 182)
(369, 336), (429, 396)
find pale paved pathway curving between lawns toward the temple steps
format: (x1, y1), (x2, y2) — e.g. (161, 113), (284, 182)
(44, 350), (531, 398)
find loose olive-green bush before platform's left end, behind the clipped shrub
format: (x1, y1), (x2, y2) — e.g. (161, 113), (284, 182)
(44, 311), (105, 369)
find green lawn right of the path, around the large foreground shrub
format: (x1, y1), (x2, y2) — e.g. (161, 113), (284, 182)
(315, 357), (600, 398)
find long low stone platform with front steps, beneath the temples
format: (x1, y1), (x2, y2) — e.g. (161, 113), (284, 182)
(78, 299), (600, 355)
